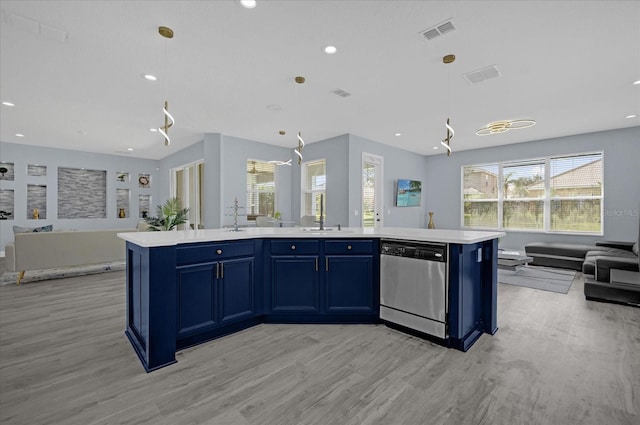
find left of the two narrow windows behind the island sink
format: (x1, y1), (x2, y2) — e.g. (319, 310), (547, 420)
(247, 159), (276, 220)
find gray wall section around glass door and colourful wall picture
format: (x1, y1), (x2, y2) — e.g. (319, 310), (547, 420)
(348, 134), (432, 228)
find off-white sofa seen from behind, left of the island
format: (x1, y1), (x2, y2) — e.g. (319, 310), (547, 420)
(5, 229), (136, 284)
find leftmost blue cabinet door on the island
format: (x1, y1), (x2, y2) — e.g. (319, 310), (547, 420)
(177, 263), (218, 337)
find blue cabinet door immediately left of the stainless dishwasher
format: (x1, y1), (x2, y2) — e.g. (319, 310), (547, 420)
(325, 255), (376, 314)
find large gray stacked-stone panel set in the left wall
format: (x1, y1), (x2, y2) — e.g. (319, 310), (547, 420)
(58, 167), (107, 218)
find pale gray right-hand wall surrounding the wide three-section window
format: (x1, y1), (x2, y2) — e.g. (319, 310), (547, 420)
(423, 127), (640, 249)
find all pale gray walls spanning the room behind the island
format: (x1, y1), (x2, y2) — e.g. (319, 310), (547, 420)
(0, 127), (640, 250)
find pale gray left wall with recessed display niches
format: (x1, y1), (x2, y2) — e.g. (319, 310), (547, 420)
(0, 142), (164, 252)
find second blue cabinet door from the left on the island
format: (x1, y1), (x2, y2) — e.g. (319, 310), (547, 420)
(219, 257), (255, 323)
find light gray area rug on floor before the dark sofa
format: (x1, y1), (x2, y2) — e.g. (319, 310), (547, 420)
(498, 266), (576, 294)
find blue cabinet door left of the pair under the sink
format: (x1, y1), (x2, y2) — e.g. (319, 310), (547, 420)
(271, 256), (320, 313)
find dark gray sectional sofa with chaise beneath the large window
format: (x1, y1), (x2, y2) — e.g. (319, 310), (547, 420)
(525, 215), (640, 306)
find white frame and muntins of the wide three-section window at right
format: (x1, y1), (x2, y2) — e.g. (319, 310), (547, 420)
(460, 151), (605, 236)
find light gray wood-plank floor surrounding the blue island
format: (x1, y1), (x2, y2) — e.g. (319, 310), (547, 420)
(0, 272), (640, 425)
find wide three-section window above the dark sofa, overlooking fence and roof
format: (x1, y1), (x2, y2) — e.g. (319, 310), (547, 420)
(462, 152), (603, 234)
